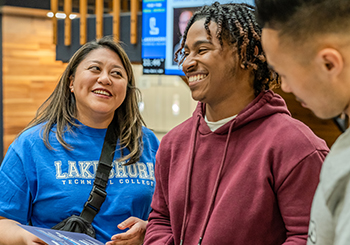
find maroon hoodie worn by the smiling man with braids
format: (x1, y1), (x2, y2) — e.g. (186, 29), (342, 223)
(144, 91), (329, 245)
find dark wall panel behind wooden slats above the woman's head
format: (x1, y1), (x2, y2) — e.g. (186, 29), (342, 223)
(56, 13), (142, 63)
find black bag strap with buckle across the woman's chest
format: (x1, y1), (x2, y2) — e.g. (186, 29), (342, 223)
(80, 118), (117, 223)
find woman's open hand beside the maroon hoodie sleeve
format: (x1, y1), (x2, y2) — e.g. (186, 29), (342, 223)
(106, 217), (148, 245)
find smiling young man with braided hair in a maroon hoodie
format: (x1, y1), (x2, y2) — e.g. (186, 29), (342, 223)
(144, 2), (328, 245)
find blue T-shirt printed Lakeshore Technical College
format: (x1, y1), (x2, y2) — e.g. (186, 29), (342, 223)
(0, 121), (159, 242)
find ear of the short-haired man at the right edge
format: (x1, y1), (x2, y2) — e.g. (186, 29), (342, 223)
(316, 48), (344, 76)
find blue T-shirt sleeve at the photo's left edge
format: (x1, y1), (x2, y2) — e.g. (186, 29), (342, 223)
(0, 146), (31, 224)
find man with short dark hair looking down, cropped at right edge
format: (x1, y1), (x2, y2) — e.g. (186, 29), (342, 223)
(256, 0), (350, 245)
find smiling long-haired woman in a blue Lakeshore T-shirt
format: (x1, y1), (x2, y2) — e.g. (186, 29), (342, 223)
(0, 37), (159, 245)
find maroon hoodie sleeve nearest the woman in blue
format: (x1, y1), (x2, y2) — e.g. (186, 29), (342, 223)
(144, 151), (174, 245)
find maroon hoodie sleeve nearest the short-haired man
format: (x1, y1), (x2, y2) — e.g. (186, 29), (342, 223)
(276, 150), (327, 245)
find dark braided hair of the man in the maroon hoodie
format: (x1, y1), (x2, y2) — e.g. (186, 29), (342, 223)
(175, 2), (280, 95)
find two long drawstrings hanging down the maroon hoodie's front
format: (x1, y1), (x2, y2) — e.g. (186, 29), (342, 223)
(180, 116), (235, 245)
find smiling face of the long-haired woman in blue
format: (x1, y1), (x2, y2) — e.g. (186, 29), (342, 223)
(69, 48), (128, 128)
